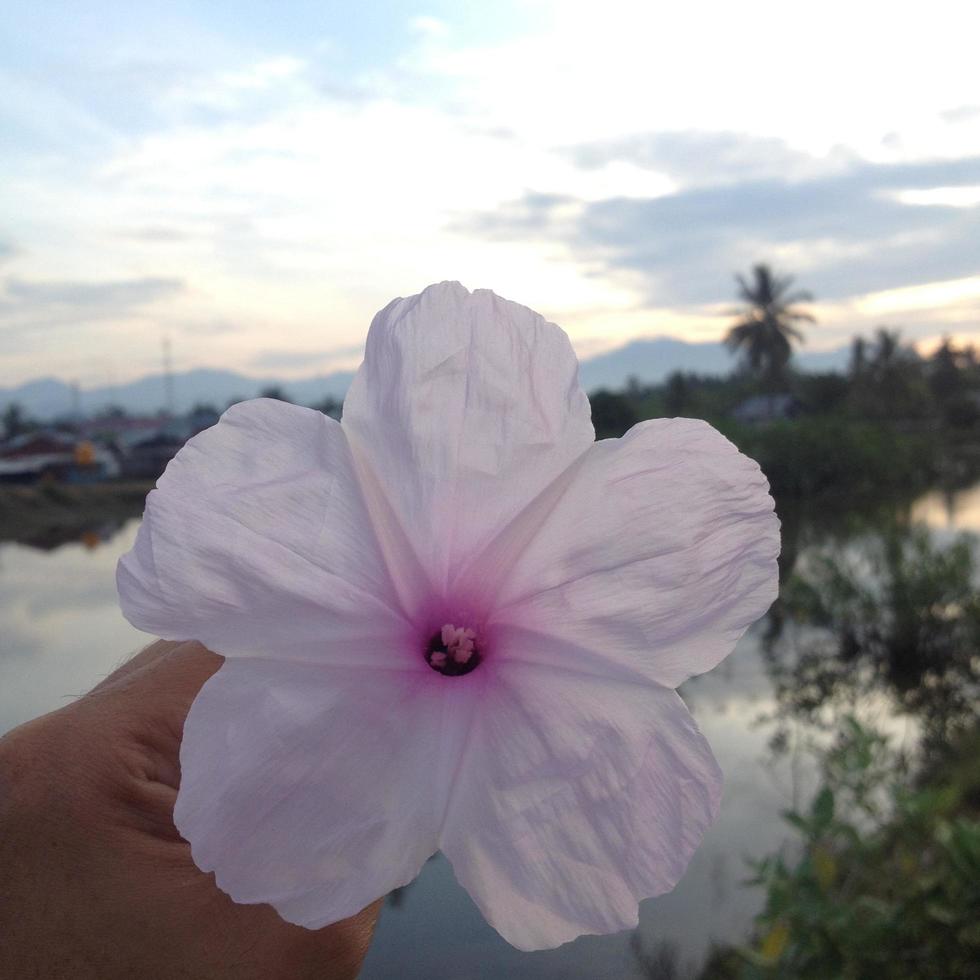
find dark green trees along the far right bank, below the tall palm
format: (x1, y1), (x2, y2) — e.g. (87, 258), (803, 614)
(592, 318), (980, 510)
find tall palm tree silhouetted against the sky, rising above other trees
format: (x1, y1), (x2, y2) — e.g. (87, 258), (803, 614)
(725, 264), (815, 385)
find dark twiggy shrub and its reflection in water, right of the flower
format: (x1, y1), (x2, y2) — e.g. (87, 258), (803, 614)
(766, 520), (980, 764)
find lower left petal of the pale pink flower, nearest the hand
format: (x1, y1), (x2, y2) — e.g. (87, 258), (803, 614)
(174, 659), (441, 928)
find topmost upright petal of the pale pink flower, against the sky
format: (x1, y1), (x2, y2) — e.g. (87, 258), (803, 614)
(343, 283), (594, 586)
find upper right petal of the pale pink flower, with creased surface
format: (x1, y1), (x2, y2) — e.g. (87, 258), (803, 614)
(488, 419), (779, 687)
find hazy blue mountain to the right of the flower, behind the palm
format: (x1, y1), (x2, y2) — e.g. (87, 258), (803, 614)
(580, 337), (850, 391)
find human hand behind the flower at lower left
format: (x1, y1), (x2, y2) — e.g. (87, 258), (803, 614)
(0, 641), (380, 980)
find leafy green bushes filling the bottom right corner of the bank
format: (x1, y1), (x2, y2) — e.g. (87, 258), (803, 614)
(703, 718), (980, 980)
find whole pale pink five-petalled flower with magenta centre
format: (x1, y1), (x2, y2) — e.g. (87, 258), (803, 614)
(118, 283), (779, 950)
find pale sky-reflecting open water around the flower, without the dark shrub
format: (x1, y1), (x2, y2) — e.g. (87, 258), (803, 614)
(0, 487), (980, 980)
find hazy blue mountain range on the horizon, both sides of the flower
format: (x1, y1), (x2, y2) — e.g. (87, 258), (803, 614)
(0, 337), (848, 419)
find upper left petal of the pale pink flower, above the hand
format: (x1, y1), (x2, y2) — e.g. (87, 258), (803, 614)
(117, 399), (408, 666)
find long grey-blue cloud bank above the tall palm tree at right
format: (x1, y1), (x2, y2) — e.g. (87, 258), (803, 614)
(465, 144), (980, 306)
